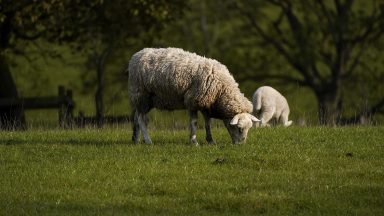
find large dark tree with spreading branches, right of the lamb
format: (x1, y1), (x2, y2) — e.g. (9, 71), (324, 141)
(234, 0), (384, 125)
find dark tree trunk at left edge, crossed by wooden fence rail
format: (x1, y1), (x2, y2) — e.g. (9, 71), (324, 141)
(0, 54), (26, 130)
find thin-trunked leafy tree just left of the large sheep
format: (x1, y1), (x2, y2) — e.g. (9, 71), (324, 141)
(73, 0), (184, 126)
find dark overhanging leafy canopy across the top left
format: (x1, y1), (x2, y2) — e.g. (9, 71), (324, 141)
(0, 0), (183, 48)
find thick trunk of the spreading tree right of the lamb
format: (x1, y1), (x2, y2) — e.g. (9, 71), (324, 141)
(316, 90), (342, 126)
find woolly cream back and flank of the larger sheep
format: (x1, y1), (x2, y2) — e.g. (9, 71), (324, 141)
(129, 48), (237, 110)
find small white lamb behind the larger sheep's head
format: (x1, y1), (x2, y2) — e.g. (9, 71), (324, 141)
(252, 86), (292, 127)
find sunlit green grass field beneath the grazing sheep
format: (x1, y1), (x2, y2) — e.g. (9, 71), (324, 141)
(0, 127), (384, 215)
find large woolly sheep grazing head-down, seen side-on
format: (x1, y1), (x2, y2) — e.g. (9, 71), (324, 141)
(128, 48), (260, 145)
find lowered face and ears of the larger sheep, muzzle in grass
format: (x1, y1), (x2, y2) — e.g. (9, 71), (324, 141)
(223, 113), (260, 144)
